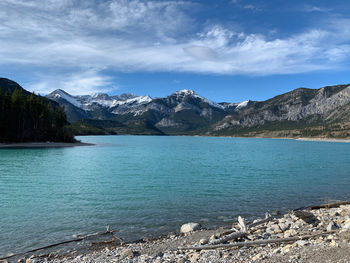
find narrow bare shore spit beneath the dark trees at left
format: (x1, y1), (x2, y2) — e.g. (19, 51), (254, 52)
(0, 142), (94, 149)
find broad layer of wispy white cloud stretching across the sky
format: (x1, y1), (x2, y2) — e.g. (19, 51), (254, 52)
(0, 0), (350, 94)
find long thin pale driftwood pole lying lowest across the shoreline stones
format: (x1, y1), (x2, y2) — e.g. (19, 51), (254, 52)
(178, 231), (335, 250)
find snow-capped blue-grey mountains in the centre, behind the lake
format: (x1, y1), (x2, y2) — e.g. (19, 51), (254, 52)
(47, 90), (251, 134)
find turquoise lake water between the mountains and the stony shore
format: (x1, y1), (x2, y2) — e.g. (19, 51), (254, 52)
(0, 136), (350, 256)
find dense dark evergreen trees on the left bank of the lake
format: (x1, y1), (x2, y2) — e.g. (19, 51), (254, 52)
(0, 89), (74, 142)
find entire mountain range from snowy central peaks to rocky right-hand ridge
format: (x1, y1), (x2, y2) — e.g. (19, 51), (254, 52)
(46, 85), (350, 138)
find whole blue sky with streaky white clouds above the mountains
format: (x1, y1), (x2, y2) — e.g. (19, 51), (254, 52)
(0, 0), (350, 102)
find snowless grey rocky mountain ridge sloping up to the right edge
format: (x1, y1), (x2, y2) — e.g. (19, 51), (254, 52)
(212, 85), (350, 137)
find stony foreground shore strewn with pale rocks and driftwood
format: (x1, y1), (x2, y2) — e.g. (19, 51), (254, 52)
(4, 203), (350, 263)
